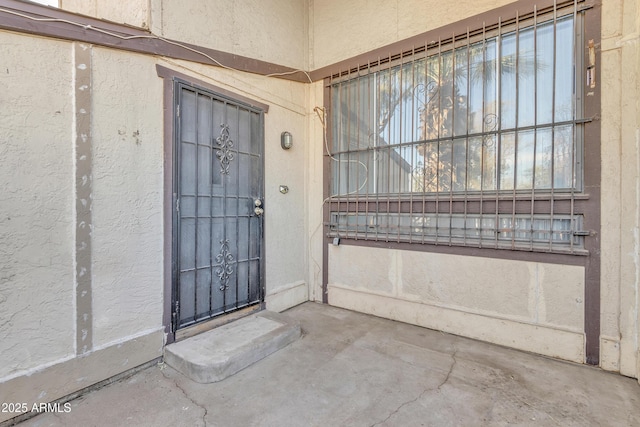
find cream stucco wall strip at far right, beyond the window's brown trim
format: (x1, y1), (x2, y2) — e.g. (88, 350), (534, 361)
(600, 0), (640, 377)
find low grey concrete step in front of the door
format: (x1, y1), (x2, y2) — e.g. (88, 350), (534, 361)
(164, 311), (301, 383)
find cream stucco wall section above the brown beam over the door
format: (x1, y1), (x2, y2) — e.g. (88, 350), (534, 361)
(60, 0), (309, 70)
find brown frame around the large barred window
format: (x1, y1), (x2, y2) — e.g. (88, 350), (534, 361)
(324, 0), (599, 256)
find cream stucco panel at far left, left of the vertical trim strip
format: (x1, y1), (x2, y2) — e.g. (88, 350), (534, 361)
(0, 32), (75, 378)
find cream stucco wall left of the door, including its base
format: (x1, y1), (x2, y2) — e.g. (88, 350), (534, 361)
(0, 32), (164, 421)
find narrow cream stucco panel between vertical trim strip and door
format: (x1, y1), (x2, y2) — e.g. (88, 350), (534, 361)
(92, 47), (163, 347)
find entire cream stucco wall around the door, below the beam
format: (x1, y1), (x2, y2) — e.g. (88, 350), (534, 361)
(0, 12), (309, 422)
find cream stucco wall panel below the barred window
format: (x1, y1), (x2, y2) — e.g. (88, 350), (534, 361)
(329, 245), (584, 362)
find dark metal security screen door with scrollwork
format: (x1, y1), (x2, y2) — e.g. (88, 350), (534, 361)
(173, 81), (263, 331)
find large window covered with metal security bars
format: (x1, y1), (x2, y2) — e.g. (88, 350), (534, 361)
(327, 1), (588, 254)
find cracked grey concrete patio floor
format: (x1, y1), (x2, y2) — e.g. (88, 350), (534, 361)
(20, 303), (640, 427)
